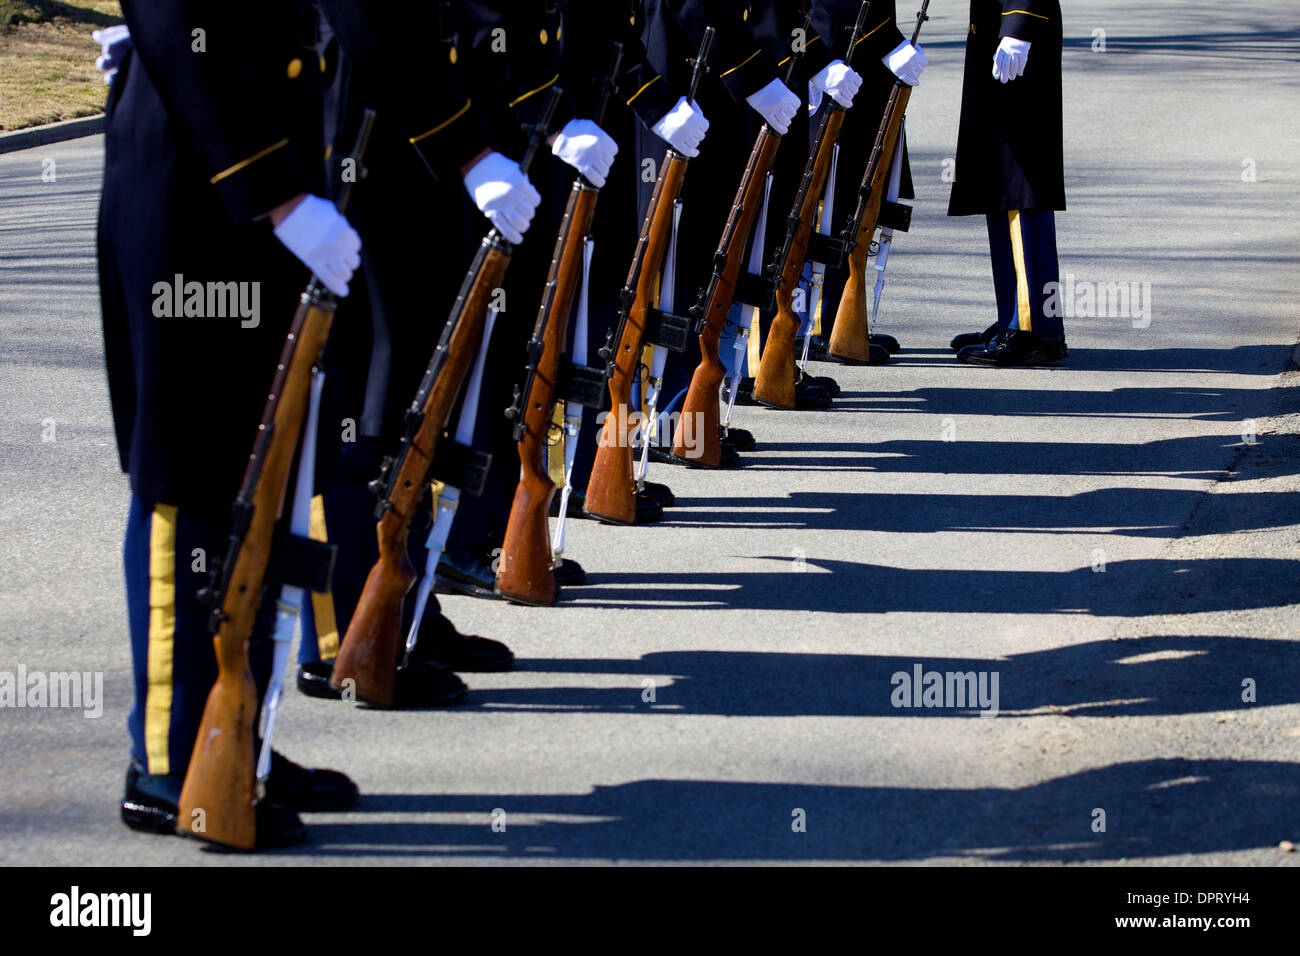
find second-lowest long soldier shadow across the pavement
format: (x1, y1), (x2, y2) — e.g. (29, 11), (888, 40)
(465, 637), (1300, 719)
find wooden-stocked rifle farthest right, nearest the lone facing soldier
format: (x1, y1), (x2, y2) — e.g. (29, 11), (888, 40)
(829, 0), (930, 363)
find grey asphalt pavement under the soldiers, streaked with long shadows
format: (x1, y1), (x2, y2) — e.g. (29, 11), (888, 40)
(0, 0), (1300, 865)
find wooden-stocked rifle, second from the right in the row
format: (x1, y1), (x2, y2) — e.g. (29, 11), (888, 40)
(754, 3), (871, 408)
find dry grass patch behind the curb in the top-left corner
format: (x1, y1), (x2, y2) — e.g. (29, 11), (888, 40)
(0, 0), (122, 130)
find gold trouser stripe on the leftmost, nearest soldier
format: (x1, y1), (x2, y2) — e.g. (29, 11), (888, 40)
(144, 505), (177, 774)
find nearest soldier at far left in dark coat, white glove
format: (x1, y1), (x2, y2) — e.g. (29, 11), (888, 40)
(99, 0), (359, 845)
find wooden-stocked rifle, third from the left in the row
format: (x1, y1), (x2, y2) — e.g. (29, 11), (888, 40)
(497, 43), (623, 605)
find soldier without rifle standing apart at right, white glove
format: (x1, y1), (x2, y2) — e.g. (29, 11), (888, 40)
(948, 0), (1067, 365)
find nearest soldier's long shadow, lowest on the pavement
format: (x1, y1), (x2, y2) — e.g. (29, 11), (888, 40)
(292, 764), (1300, 862)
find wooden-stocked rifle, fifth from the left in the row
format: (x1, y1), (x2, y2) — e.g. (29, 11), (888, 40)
(672, 10), (813, 468)
